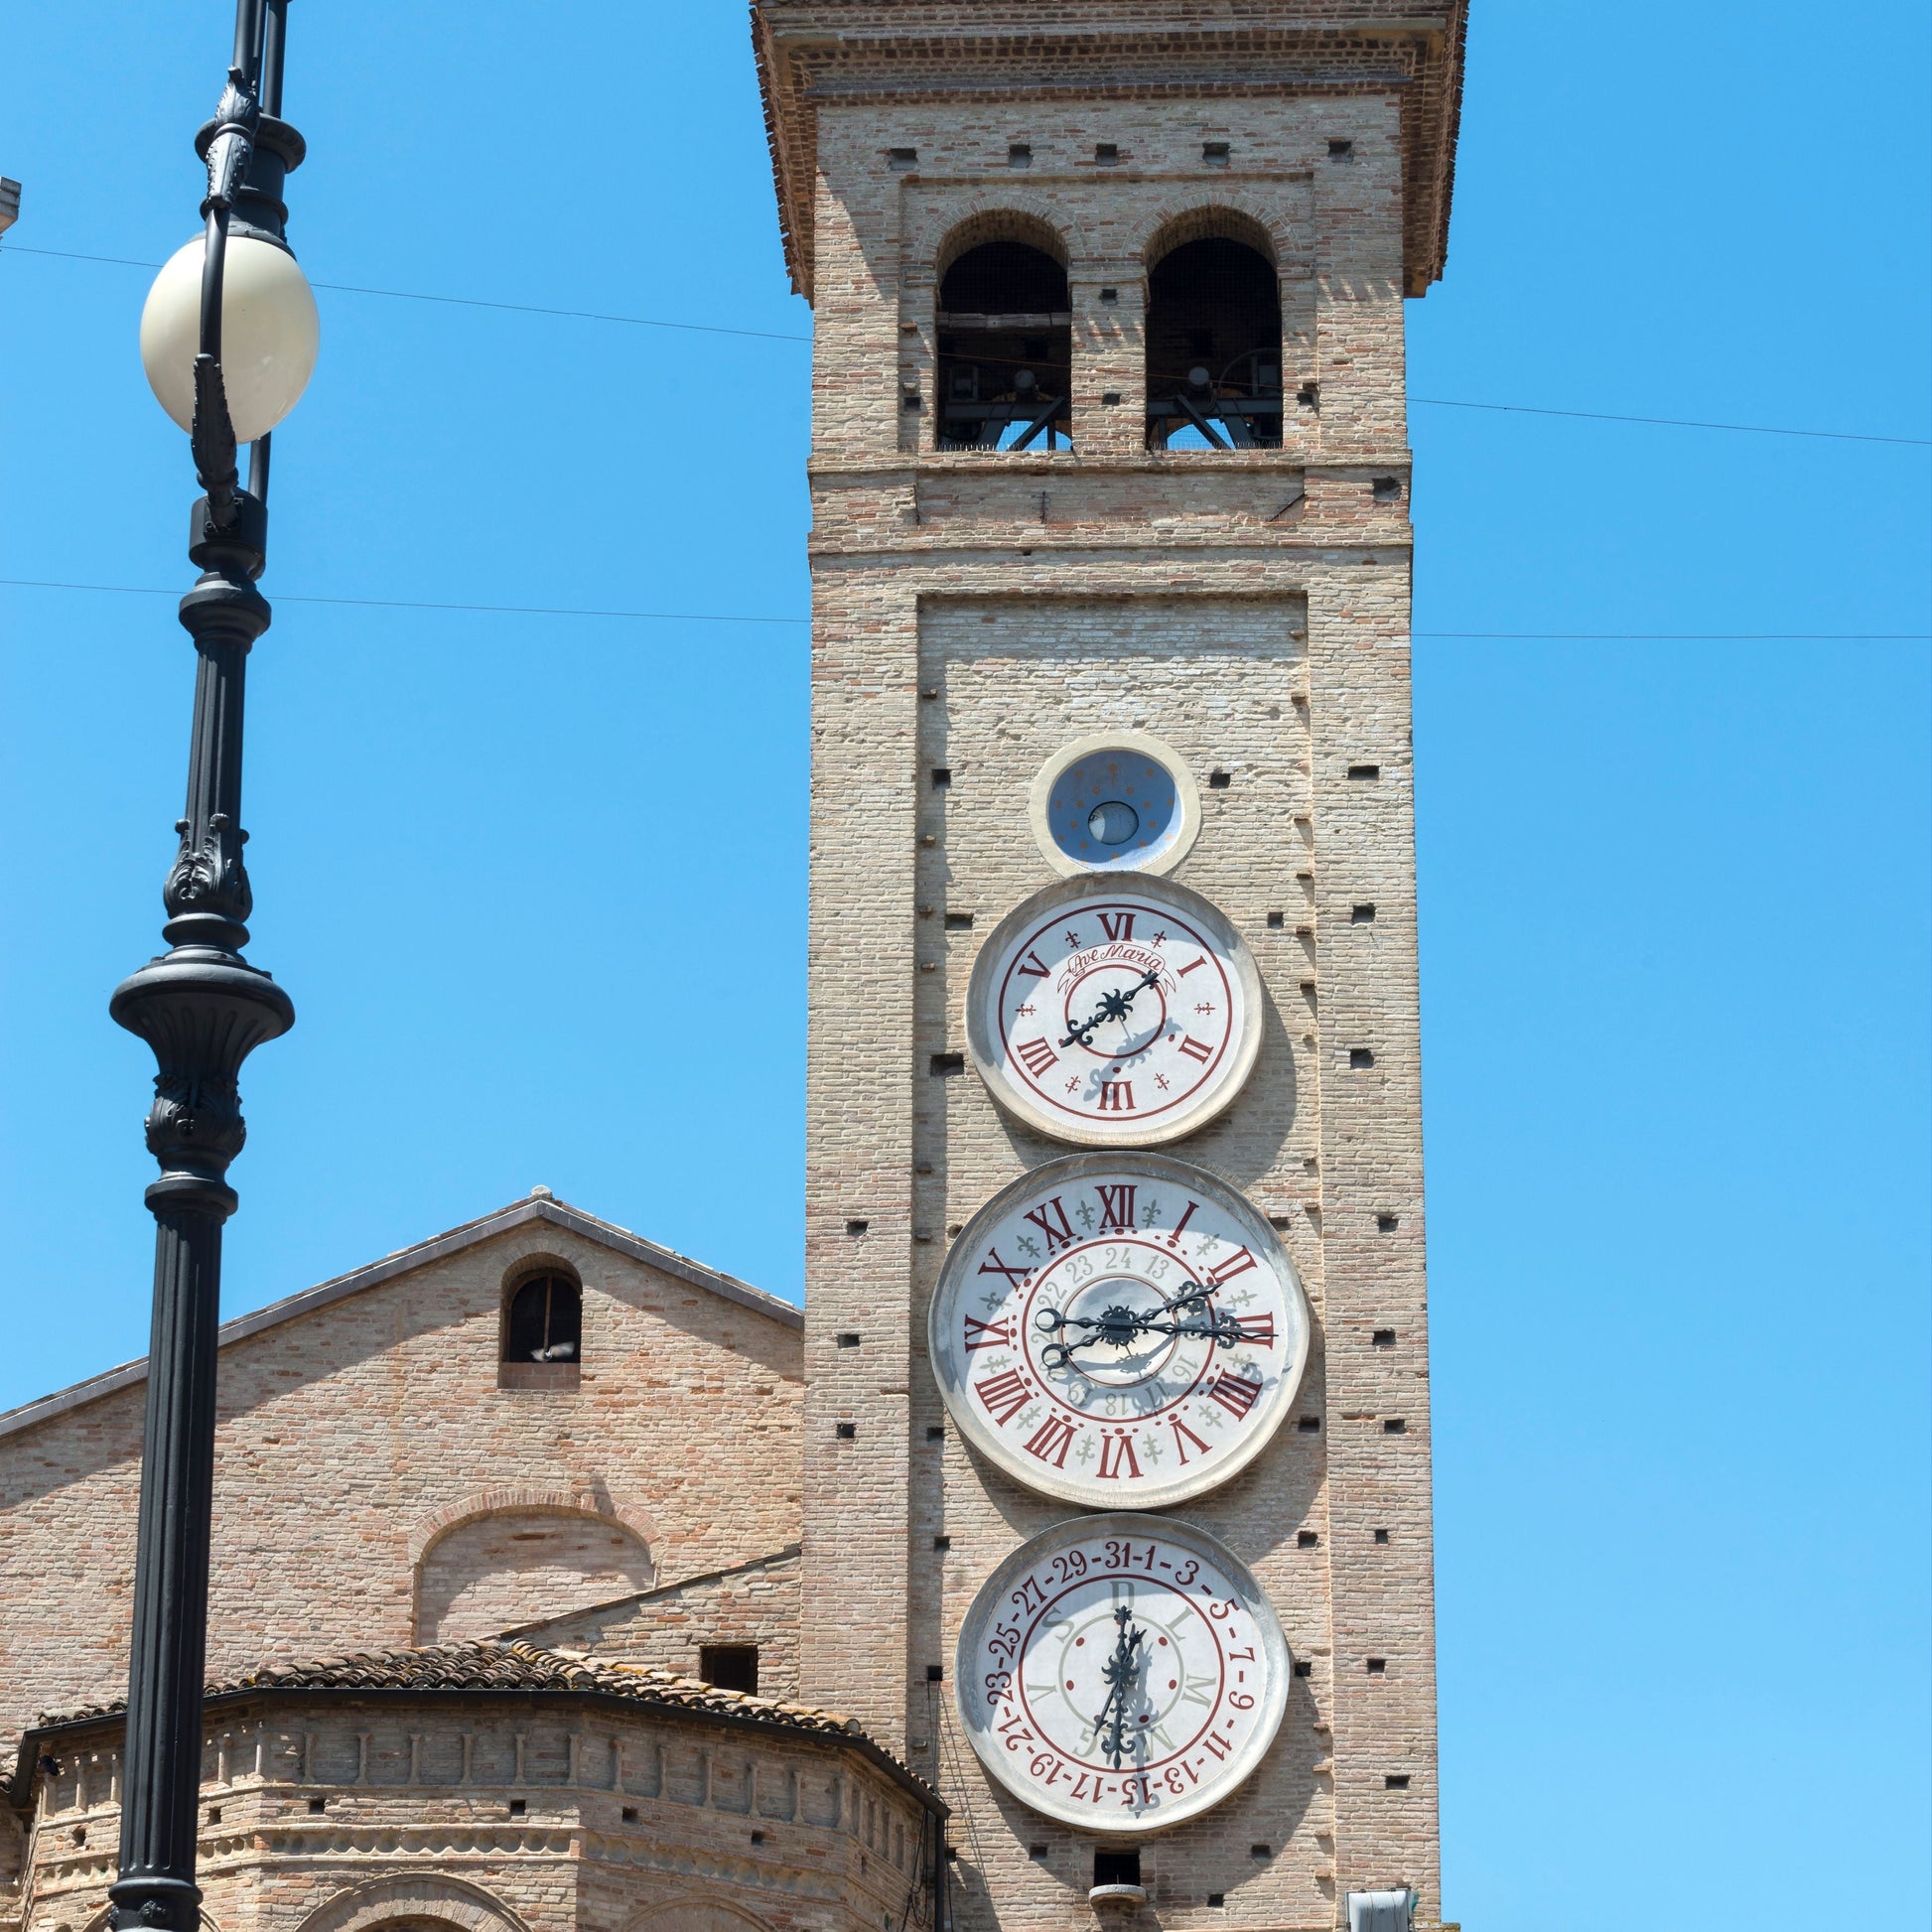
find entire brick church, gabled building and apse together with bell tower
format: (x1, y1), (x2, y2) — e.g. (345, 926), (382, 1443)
(0, 11), (1462, 1932)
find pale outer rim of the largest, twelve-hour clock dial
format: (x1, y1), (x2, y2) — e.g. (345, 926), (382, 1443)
(925, 1150), (1313, 1511)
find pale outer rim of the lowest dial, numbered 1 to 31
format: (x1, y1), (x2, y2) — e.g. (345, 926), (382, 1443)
(952, 1509), (1295, 1838)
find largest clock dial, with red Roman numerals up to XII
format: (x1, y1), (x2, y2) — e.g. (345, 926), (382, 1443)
(927, 1154), (1308, 1509)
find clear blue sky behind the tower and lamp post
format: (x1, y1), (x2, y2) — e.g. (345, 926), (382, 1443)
(0, 0), (1932, 1932)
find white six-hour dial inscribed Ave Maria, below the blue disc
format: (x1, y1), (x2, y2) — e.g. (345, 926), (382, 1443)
(966, 876), (1262, 1148)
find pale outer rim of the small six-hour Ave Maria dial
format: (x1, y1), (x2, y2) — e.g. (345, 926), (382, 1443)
(966, 872), (1266, 1148)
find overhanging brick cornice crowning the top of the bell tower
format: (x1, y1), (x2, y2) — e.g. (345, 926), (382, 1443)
(752, 0), (1466, 302)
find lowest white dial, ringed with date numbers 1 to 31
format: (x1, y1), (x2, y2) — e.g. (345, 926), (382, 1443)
(954, 1513), (1289, 1832)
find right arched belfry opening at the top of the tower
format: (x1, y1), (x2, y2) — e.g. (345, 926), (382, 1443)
(1148, 235), (1281, 450)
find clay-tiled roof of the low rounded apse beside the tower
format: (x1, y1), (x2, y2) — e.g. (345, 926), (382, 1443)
(8, 1638), (947, 1816)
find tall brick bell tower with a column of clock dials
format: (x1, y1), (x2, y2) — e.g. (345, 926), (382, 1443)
(754, 0), (1462, 1932)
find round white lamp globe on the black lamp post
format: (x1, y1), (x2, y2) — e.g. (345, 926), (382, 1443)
(141, 235), (323, 443)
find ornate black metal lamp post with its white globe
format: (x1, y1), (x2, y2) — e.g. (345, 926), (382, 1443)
(108, 0), (317, 1932)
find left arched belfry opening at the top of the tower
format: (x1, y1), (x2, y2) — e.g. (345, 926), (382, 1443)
(937, 241), (1074, 450)
